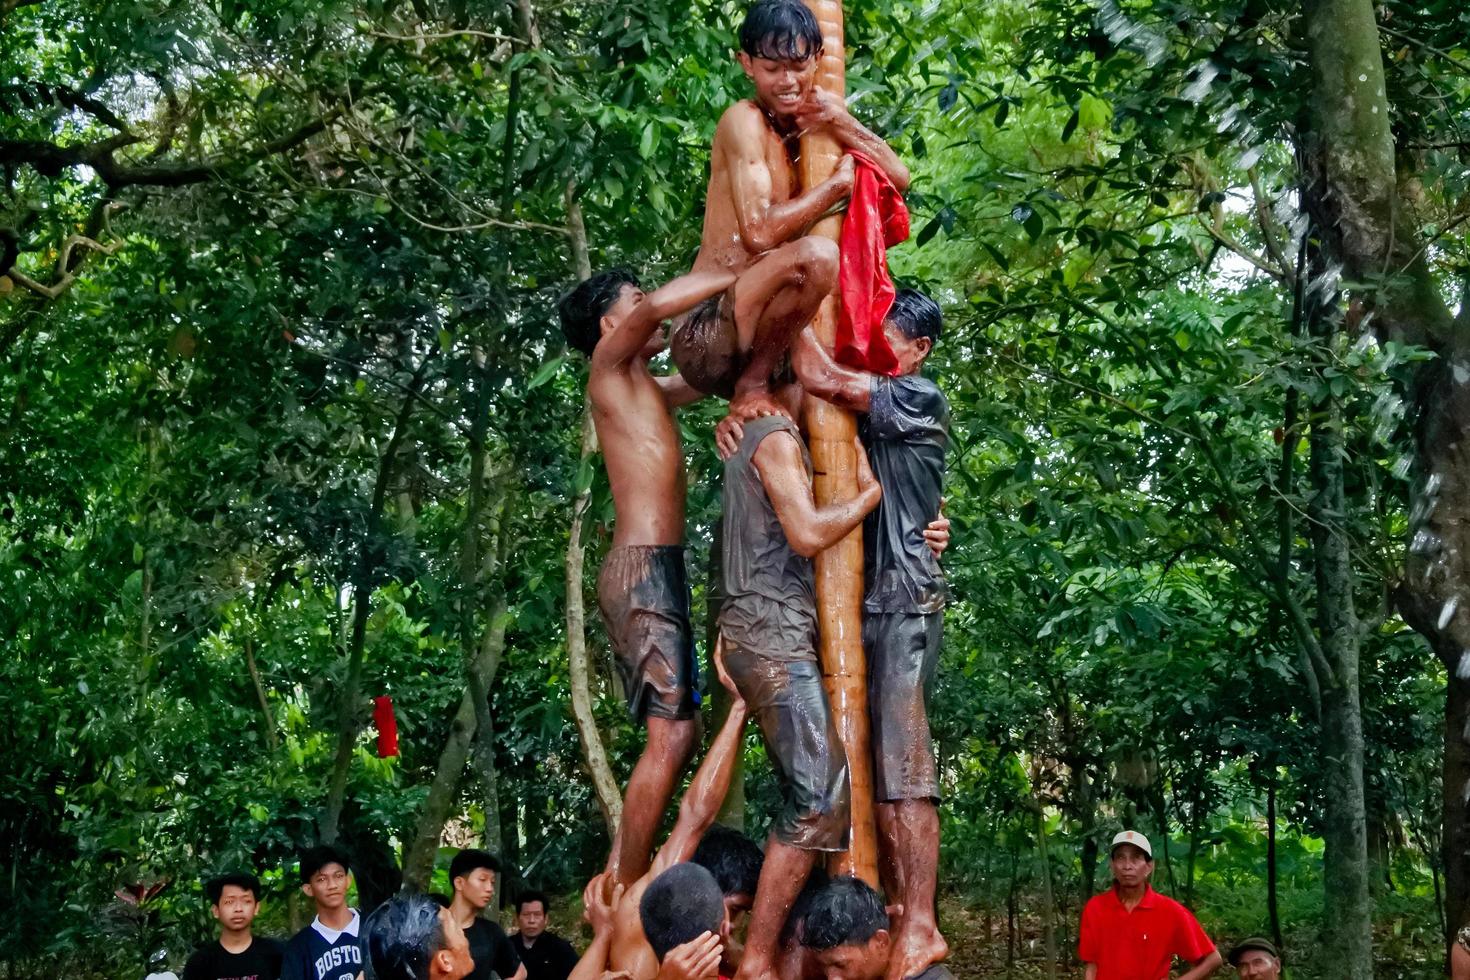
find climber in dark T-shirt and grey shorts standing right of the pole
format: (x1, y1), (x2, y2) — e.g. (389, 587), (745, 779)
(791, 289), (950, 980)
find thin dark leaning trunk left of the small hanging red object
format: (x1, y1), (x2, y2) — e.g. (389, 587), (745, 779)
(318, 364), (431, 843)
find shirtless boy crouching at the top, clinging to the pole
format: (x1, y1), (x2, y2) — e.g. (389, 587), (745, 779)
(670, 0), (908, 417)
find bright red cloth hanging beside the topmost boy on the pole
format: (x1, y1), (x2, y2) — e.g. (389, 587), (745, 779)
(832, 150), (908, 375)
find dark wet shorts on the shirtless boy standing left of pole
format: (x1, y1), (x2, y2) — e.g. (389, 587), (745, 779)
(597, 545), (698, 721)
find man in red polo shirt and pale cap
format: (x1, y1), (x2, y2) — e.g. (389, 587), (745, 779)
(1078, 830), (1222, 980)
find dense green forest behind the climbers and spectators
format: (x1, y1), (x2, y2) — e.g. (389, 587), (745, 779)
(0, 0), (1470, 980)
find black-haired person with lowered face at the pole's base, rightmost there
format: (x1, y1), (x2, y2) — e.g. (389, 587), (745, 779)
(798, 877), (954, 980)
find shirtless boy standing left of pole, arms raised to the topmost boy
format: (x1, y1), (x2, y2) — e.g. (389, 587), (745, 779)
(559, 262), (735, 884)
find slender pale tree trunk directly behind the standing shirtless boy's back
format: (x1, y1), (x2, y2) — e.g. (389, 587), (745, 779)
(566, 182), (623, 840)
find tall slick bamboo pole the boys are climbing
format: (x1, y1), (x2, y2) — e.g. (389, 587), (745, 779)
(800, 0), (878, 886)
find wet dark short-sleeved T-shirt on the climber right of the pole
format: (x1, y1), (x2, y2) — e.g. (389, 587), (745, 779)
(860, 375), (950, 613)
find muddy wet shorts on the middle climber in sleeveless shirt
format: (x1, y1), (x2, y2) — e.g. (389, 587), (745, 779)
(725, 636), (851, 851)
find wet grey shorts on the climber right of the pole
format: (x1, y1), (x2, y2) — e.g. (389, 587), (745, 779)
(863, 611), (944, 802)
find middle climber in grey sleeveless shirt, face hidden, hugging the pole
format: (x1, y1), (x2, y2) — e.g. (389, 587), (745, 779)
(719, 405), (882, 980)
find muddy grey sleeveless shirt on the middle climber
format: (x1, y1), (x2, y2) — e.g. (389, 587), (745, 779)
(720, 416), (817, 658)
